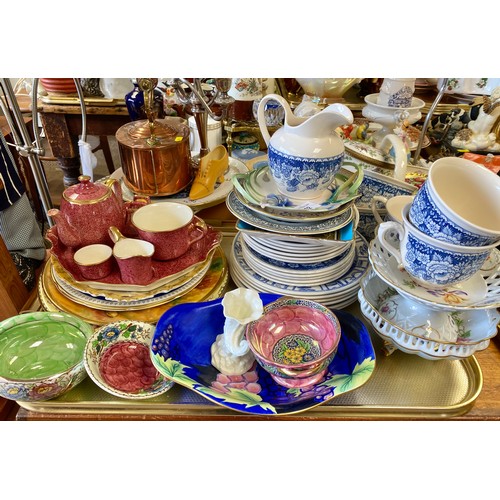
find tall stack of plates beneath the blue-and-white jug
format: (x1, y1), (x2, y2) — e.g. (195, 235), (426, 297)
(226, 166), (368, 308)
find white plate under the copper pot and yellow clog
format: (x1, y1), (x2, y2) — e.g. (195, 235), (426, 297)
(110, 157), (248, 212)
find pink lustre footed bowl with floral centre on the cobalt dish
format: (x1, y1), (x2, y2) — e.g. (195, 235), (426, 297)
(246, 297), (341, 389)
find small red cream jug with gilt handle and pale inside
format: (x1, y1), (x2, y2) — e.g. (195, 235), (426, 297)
(109, 226), (155, 285)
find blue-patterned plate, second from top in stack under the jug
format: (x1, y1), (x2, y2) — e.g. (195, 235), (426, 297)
(226, 191), (355, 235)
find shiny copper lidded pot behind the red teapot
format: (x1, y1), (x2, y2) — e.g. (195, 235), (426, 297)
(116, 117), (193, 196)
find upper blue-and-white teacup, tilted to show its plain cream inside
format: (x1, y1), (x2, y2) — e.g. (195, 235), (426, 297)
(409, 157), (500, 247)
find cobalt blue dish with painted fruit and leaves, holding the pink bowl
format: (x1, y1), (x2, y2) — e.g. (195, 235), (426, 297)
(150, 293), (375, 415)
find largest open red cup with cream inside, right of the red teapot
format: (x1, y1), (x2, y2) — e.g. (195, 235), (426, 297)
(132, 202), (207, 260)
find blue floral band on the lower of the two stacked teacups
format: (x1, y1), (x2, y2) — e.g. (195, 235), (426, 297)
(406, 233), (490, 285)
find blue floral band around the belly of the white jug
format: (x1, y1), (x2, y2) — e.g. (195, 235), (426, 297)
(268, 144), (344, 193)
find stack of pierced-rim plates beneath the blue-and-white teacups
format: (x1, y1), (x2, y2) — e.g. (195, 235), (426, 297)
(364, 234), (500, 360)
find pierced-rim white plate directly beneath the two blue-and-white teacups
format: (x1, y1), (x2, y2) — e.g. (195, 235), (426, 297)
(369, 238), (500, 310)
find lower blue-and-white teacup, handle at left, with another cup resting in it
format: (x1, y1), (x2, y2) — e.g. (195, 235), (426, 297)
(377, 204), (495, 290)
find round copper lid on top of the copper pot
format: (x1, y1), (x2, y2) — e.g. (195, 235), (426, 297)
(116, 117), (189, 149)
